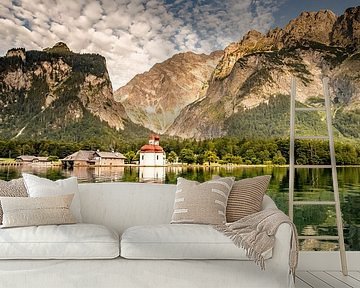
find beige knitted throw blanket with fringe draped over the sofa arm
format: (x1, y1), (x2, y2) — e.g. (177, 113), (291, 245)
(214, 209), (299, 276)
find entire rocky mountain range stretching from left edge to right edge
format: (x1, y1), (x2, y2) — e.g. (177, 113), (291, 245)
(0, 6), (360, 143)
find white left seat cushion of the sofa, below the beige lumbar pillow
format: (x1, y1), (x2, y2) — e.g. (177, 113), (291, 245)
(0, 224), (119, 259)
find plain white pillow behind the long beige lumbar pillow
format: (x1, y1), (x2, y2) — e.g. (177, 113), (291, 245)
(22, 173), (82, 223)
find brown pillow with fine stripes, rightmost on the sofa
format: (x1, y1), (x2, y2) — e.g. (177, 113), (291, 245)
(226, 175), (271, 222)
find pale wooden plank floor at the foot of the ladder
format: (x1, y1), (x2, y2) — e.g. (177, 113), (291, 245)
(295, 272), (360, 288)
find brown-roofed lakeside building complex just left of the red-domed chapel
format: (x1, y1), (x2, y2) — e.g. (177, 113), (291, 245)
(61, 150), (126, 168)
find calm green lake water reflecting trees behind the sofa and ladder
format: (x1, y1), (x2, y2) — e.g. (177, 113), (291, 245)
(0, 165), (360, 251)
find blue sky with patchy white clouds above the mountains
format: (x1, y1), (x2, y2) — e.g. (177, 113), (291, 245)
(0, 0), (359, 90)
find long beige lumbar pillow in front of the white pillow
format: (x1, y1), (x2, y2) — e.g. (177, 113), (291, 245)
(0, 194), (76, 228)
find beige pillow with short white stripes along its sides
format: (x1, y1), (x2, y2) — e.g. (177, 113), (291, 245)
(171, 177), (234, 225)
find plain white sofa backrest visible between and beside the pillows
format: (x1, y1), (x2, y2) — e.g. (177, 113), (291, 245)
(79, 182), (276, 234)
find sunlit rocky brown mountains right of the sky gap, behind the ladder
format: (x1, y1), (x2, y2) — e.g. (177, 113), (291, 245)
(115, 6), (360, 139)
